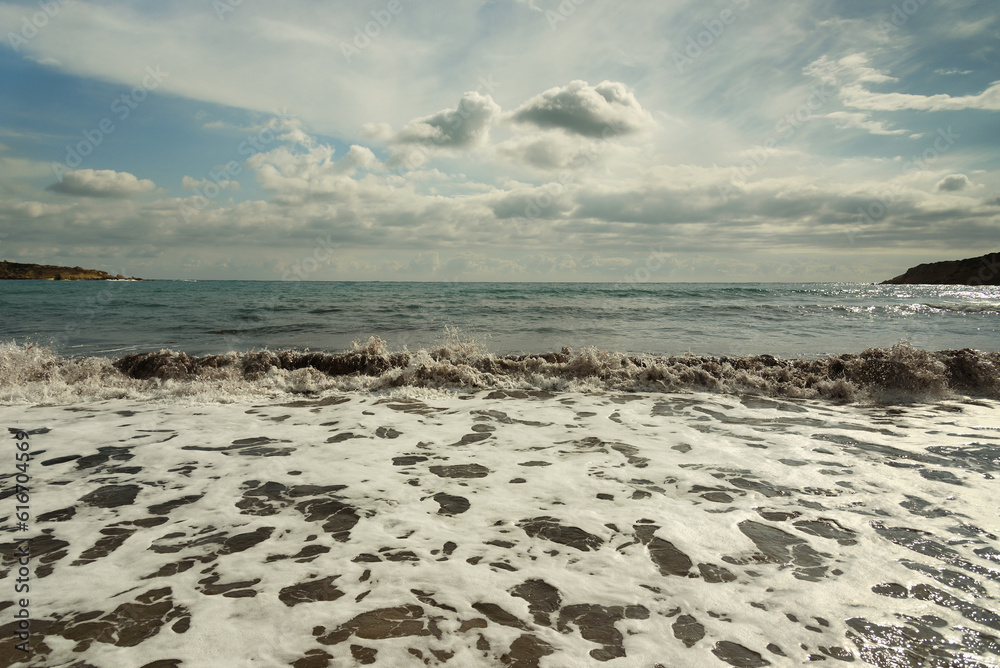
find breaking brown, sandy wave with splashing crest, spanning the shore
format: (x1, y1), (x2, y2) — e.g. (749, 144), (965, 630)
(0, 337), (1000, 404)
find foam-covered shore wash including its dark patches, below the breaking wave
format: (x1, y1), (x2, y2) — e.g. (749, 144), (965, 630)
(0, 389), (1000, 667)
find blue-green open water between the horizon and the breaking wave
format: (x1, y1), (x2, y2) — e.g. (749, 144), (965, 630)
(0, 281), (1000, 357)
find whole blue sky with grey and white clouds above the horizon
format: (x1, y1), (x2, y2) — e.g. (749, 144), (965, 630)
(0, 0), (1000, 282)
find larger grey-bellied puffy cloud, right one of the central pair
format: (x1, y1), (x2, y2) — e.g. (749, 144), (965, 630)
(511, 80), (650, 137)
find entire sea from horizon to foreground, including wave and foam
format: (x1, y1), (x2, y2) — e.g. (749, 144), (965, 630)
(0, 281), (1000, 668)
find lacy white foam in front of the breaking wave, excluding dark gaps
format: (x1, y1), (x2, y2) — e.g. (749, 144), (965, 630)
(2, 388), (1000, 667)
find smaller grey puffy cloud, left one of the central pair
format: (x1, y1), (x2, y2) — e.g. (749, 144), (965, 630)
(393, 91), (500, 148)
